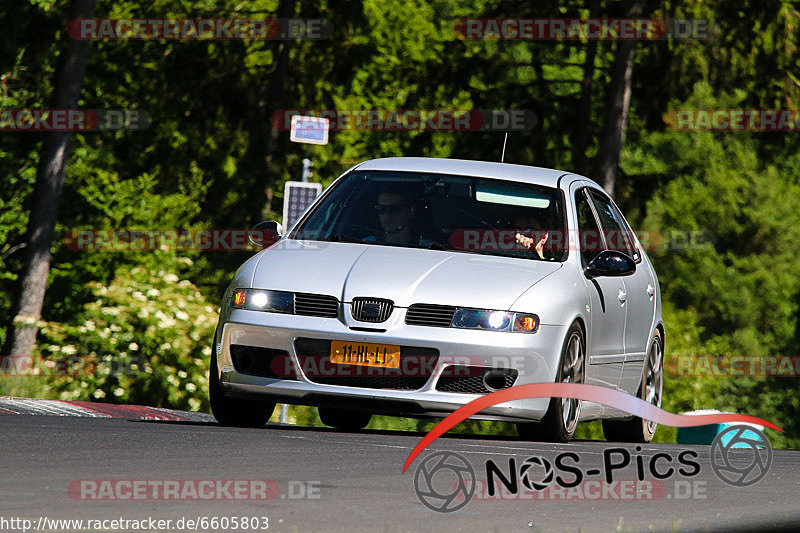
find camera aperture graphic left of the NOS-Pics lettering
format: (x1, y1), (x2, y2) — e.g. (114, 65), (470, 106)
(414, 452), (475, 513)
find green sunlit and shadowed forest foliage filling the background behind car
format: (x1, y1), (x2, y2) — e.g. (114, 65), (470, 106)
(0, 0), (800, 448)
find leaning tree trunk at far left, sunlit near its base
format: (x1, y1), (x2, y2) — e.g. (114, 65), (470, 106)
(3, 0), (96, 355)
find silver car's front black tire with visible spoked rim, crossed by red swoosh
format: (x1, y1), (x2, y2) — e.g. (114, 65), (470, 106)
(517, 322), (586, 442)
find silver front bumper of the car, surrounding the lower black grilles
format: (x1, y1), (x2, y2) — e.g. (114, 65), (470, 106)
(212, 308), (567, 421)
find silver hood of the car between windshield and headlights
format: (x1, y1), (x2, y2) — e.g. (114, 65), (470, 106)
(252, 239), (561, 310)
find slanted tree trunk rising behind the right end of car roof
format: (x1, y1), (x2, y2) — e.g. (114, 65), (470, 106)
(596, 0), (644, 197)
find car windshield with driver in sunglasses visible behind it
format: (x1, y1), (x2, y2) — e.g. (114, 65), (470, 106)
(289, 171), (565, 261)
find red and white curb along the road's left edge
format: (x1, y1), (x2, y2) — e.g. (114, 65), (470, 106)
(0, 396), (214, 422)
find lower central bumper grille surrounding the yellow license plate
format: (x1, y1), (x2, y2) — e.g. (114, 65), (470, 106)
(295, 338), (439, 390)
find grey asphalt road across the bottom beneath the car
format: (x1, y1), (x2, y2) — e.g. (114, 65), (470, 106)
(0, 414), (800, 532)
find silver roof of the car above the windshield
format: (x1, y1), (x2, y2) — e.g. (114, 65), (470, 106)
(353, 157), (596, 187)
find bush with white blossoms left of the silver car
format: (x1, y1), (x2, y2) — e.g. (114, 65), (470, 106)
(39, 258), (217, 411)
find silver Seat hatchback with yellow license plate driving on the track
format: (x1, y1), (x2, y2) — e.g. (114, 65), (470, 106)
(210, 158), (664, 442)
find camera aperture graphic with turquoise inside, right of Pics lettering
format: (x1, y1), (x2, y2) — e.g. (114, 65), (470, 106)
(710, 425), (772, 487)
